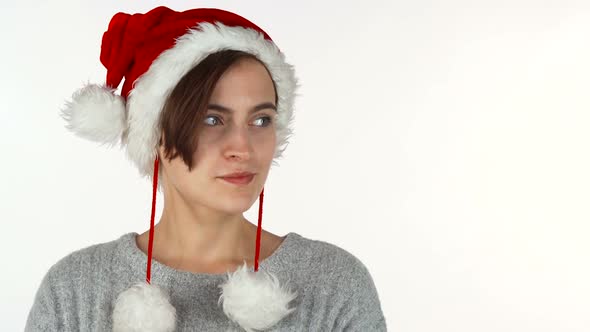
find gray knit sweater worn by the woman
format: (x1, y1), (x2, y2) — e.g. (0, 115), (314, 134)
(25, 232), (386, 332)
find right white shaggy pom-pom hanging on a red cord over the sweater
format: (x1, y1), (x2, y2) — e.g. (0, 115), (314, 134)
(219, 262), (297, 332)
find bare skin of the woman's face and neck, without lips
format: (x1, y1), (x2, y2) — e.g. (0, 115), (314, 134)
(136, 59), (284, 274)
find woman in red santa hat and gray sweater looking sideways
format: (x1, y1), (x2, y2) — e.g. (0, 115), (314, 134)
(25, 7), (386, 331)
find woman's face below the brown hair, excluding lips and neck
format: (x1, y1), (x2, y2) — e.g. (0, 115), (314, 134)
(160, 59), (277, 215)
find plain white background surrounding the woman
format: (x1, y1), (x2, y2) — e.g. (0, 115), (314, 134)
(0, 0), (590, 332)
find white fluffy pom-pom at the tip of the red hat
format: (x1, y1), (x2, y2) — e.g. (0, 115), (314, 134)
(61, 84), (126, 145)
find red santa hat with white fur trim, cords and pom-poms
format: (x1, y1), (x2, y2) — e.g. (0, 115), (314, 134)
(62, 7), (298, 332)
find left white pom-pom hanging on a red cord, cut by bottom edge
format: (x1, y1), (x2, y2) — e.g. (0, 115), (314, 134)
(113, 282), (176, 332)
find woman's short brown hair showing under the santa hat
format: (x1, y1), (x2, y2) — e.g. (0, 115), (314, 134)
(158, 50), (278, 171)
